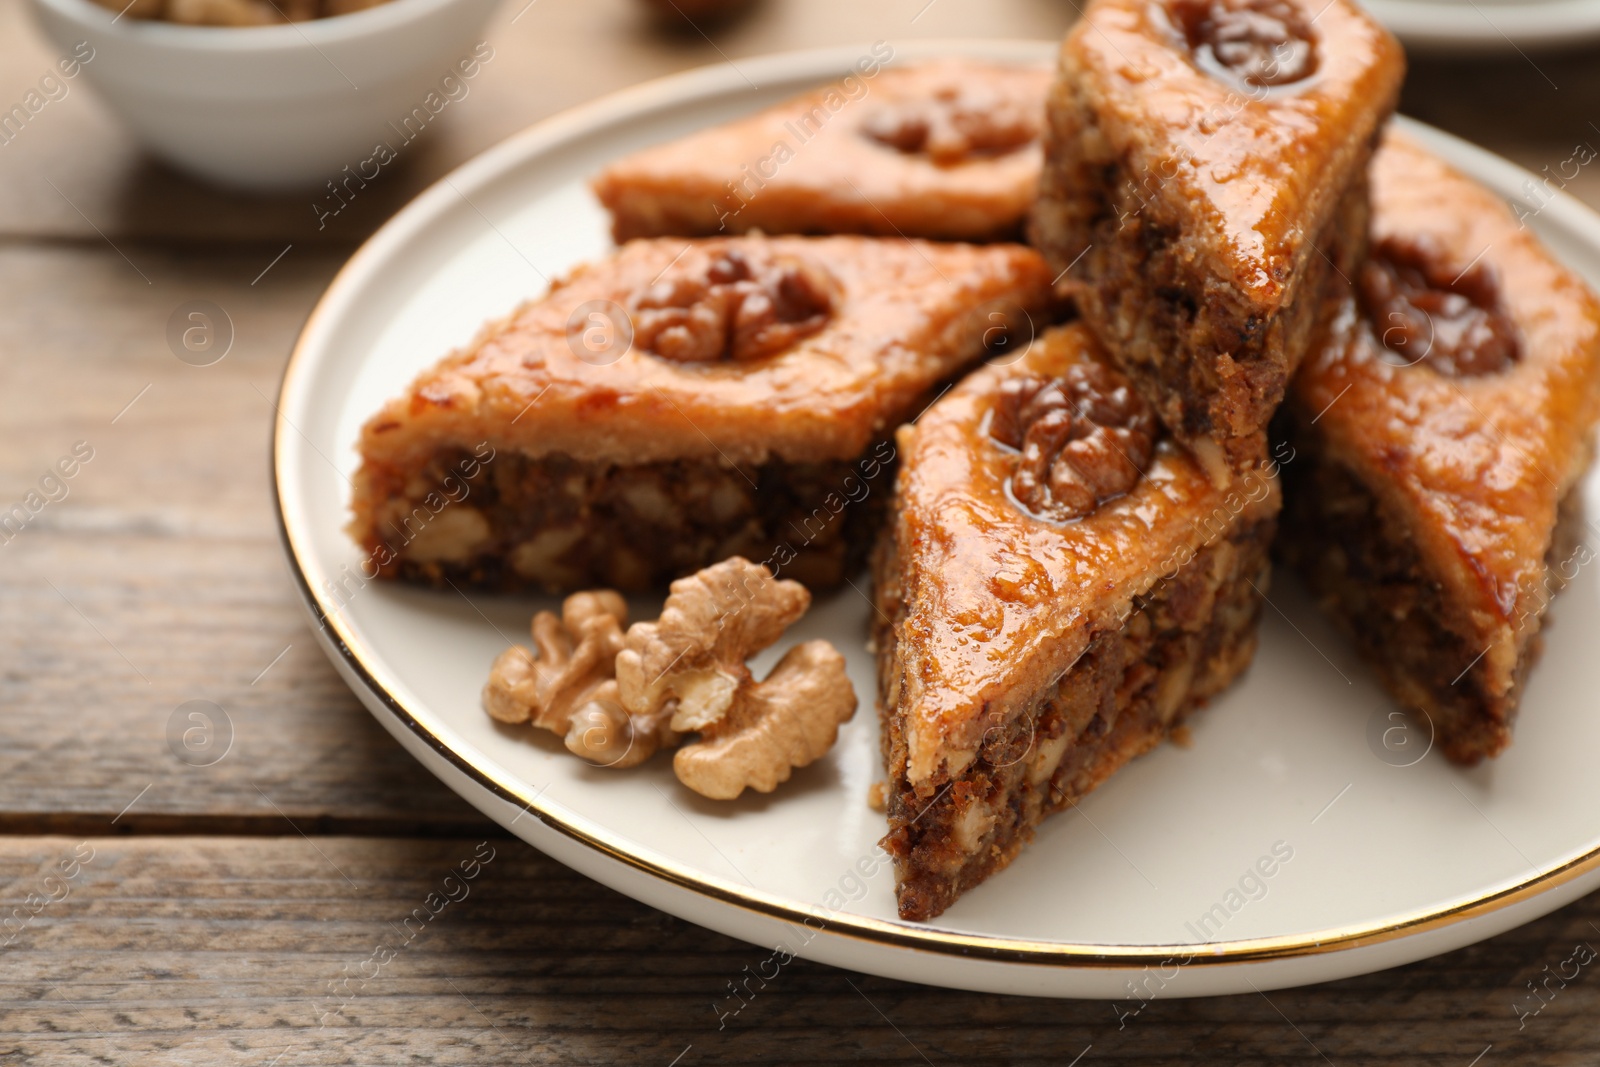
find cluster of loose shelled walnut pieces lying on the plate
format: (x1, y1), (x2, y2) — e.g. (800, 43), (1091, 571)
(483, 557), (856, 800)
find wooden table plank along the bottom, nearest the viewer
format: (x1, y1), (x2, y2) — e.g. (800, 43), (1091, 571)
(0, 837), (1600, 1067)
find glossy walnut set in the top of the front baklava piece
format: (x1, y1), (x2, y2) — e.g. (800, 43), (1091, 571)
(989, 363), (1155, 522)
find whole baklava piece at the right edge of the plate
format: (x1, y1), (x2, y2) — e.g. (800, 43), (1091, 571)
(1280, 134), (1600, 763)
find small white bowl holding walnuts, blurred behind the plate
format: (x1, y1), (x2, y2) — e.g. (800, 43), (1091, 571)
(32, 0), (499, 190)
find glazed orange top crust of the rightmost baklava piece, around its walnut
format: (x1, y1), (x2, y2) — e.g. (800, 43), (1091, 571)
(1288, 133), (1600, 691)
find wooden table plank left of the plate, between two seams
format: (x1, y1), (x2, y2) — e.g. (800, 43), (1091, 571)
(0, 246), (482, 833)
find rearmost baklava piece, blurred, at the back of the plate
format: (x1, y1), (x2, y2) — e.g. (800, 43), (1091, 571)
(594, 58), (1050, 242)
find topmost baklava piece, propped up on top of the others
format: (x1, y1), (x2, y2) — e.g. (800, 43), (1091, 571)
(1032, 0), (1403, 478)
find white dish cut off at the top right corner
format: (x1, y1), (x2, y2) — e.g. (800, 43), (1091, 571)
(1362, 0), (1600, 53)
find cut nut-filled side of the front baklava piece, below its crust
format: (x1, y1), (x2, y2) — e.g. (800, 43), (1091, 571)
(875, 502), (1274, 921)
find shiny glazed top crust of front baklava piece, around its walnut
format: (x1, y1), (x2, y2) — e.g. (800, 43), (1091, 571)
(891, 323), (1278, 785)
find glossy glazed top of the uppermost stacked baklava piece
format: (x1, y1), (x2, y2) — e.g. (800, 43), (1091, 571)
(1061, 0), (1405, 309)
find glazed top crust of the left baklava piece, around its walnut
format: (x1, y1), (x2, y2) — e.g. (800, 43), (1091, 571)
(360, 237), (1050, 467)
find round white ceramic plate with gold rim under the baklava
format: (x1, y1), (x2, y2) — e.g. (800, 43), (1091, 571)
(275, 42), (1600, 1011)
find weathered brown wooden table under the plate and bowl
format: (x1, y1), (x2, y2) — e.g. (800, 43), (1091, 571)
(0, 0), (1600, 1067)
